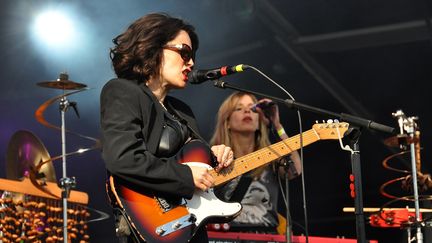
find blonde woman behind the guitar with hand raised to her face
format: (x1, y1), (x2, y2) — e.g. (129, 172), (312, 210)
(210, 92), (301, 233)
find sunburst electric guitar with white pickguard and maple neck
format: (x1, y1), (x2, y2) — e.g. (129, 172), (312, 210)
(107, 122), (349, 243)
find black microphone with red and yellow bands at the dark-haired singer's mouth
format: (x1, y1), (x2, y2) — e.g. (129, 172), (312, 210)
(188, 64), (249, 84)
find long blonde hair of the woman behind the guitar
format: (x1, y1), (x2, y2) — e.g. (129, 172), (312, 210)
(210, 91), (270, 177)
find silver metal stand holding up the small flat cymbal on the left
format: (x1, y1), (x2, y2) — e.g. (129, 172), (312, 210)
(59, 73), (76, 243)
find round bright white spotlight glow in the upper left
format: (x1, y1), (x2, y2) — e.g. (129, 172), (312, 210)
(34, 10), (74, 46)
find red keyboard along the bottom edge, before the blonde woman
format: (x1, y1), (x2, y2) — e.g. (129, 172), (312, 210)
(207, 231), (378, 243)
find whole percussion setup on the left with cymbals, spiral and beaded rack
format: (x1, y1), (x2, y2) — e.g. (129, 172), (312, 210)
(0, 73), (102, 242)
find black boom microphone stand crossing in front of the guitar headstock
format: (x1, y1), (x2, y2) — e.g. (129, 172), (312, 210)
(214, 80), (394, 243)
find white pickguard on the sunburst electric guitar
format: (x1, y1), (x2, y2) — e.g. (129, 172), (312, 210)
(185, 162), (242, 226)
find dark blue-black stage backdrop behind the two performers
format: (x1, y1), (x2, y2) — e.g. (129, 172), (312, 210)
(0, 0), (432, 242)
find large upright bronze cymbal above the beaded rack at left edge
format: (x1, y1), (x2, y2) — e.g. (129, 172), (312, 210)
(6, 130), (57, 182)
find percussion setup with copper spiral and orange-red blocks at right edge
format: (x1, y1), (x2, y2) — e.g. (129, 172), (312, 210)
(343, 110), (432, 243)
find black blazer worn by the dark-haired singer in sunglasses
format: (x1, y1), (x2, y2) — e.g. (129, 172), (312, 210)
(100, 79), (198, 198)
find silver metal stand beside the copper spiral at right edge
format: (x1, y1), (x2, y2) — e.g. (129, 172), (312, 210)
(392, 110), (423, 243)
